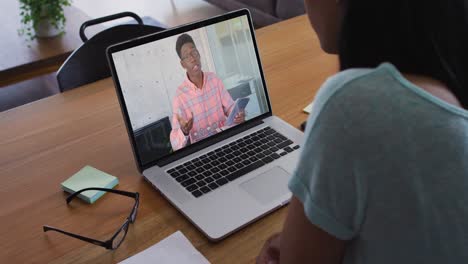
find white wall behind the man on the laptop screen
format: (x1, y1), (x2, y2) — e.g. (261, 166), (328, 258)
(113, 28), (216, 130)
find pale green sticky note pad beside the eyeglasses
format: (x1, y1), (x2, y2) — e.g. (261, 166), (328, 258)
(62, 166), (119, 203)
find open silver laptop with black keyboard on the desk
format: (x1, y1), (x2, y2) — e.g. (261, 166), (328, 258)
(107, 9), (303, 241)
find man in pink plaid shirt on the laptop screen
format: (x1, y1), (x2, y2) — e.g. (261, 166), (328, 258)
(170, 34), (245, 150)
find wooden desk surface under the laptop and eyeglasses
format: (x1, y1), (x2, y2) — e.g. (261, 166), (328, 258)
(0, 17), (338, 263)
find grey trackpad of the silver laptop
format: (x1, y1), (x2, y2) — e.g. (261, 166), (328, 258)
(240, 167), (291, 204)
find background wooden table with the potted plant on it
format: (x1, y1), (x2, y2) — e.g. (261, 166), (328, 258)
(0, 0), (99, 87)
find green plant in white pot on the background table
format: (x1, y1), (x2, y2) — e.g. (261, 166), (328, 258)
(19, 0), (71, 40)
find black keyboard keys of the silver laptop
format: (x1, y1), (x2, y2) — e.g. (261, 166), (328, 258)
(167, 127), (299, 197)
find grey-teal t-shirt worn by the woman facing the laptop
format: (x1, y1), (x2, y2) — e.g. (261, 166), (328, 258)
(289, 63), (468, 264)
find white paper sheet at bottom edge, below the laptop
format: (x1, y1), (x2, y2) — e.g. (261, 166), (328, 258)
(120, 231), (210, 264)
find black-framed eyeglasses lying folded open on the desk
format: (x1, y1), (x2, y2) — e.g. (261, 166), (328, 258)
(43, 188), (140, 250)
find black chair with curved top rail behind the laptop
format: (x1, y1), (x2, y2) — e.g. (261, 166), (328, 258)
(57, 12), (164, 92)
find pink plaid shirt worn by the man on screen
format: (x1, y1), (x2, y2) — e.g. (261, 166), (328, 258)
(170, 72), (234, 150)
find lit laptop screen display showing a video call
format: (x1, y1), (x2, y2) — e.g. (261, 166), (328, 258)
(113, 16), (268, 164)
